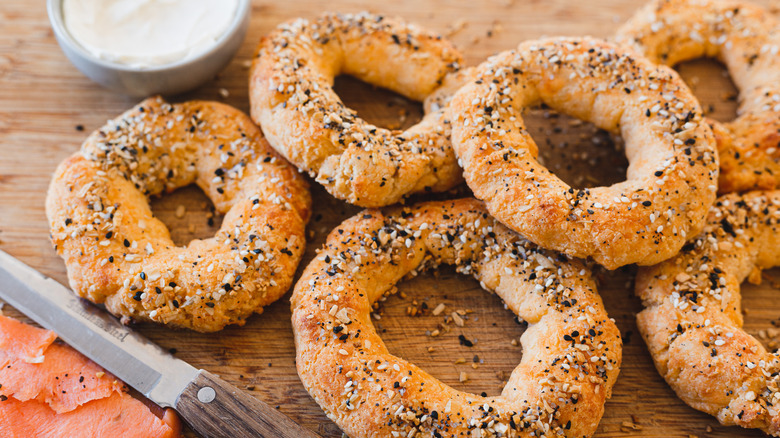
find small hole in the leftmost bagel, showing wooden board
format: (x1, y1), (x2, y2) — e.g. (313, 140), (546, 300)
(150, 184), (222, 246)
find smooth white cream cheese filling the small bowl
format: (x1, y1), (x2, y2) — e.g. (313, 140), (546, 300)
(62, 0), (238, 68)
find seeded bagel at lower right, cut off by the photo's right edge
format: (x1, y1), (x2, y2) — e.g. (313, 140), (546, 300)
(636, 191), (780, 435)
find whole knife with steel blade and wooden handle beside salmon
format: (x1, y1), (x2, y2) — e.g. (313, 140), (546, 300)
(0, 250), (318, 438)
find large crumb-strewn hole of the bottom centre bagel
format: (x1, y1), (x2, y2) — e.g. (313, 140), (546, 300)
(372, 266), (526, 396)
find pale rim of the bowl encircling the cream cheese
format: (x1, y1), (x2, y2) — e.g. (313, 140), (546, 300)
(46, 0), (252, 73)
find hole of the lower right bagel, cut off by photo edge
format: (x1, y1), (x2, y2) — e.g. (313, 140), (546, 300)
(741, 268), (780, 351)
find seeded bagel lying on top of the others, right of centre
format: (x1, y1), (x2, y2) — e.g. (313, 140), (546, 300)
(450, 38), (718, 269)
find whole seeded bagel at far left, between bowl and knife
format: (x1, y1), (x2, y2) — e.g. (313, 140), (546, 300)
(46, 98), (311, 332)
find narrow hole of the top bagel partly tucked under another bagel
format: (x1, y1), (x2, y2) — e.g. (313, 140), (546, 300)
(333, 75), (423, 131)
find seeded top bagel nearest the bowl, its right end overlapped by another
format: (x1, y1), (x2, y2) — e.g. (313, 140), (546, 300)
(249, 13), (462, 207)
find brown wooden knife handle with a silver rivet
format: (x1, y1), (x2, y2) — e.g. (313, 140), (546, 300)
(176, 370), (319, 438)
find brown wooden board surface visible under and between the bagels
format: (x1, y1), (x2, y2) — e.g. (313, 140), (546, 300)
(0, 0), (780, 437)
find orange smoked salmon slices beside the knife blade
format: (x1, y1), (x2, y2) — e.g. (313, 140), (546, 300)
(0, 315), (181, 438)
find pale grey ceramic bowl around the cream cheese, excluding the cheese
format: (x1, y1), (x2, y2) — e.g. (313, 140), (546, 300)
(46, 0), (251, 97)
